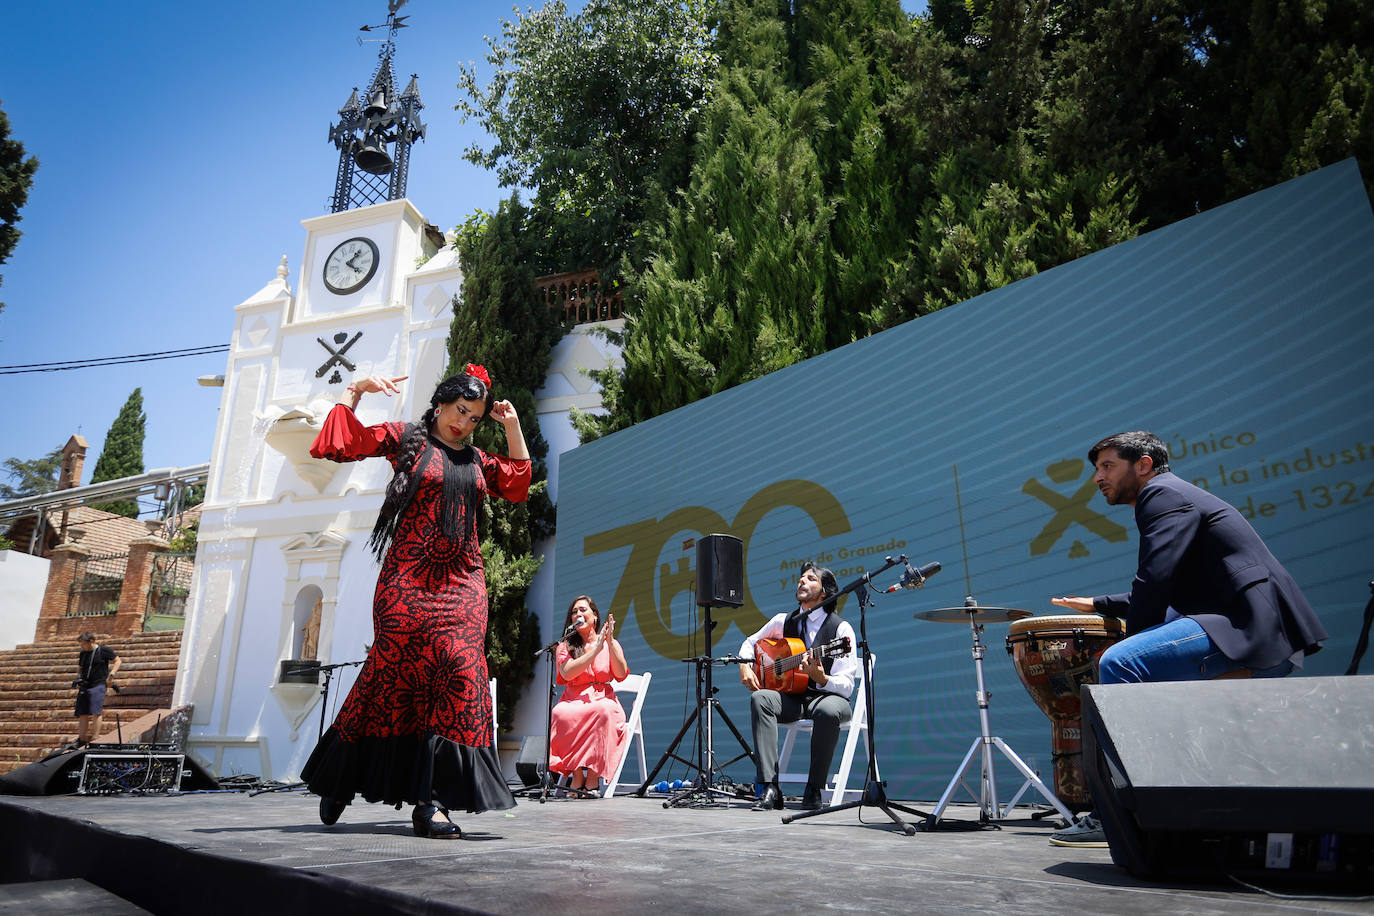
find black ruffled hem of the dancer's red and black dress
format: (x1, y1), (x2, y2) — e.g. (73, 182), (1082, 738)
(301, 726), (515, 814)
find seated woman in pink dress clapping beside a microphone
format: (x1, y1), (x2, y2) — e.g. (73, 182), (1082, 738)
(548, 595), (629, 795)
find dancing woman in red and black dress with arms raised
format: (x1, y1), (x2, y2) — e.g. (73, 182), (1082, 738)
(301, 364), (530, 839)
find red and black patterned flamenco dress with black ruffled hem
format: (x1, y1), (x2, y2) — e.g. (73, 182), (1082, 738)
(301, 405), (530, 813)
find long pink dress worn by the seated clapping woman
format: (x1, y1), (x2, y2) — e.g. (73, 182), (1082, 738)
(548, 639), (629, 779)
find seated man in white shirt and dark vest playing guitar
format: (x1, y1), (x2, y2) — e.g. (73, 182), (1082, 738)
(739, 563), (859, 812)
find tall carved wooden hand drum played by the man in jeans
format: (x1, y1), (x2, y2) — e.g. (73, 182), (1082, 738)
(1007, 614), (1125, 810)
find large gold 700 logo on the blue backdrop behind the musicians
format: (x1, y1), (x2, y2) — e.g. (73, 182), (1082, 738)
(583, 479), (849, 658)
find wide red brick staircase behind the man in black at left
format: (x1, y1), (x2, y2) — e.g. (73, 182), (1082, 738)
(0, 630), (181, 773)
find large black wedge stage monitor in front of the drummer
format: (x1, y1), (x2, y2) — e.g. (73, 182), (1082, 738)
(1081, 676), (1374, 884)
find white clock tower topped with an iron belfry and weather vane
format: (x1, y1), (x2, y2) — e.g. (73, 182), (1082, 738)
(174, 10), (462, 779)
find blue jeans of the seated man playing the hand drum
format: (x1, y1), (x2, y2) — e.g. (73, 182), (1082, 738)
(1098, 617), (1293, 684)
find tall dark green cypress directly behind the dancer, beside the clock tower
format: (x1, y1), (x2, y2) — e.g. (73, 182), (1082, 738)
(447, 196), (563, 721)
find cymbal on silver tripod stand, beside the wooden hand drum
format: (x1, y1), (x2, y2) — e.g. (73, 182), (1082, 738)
(916, 596), (1073, 831)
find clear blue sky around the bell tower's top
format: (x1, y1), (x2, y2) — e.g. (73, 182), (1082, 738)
(0, 0), (923, 502)
